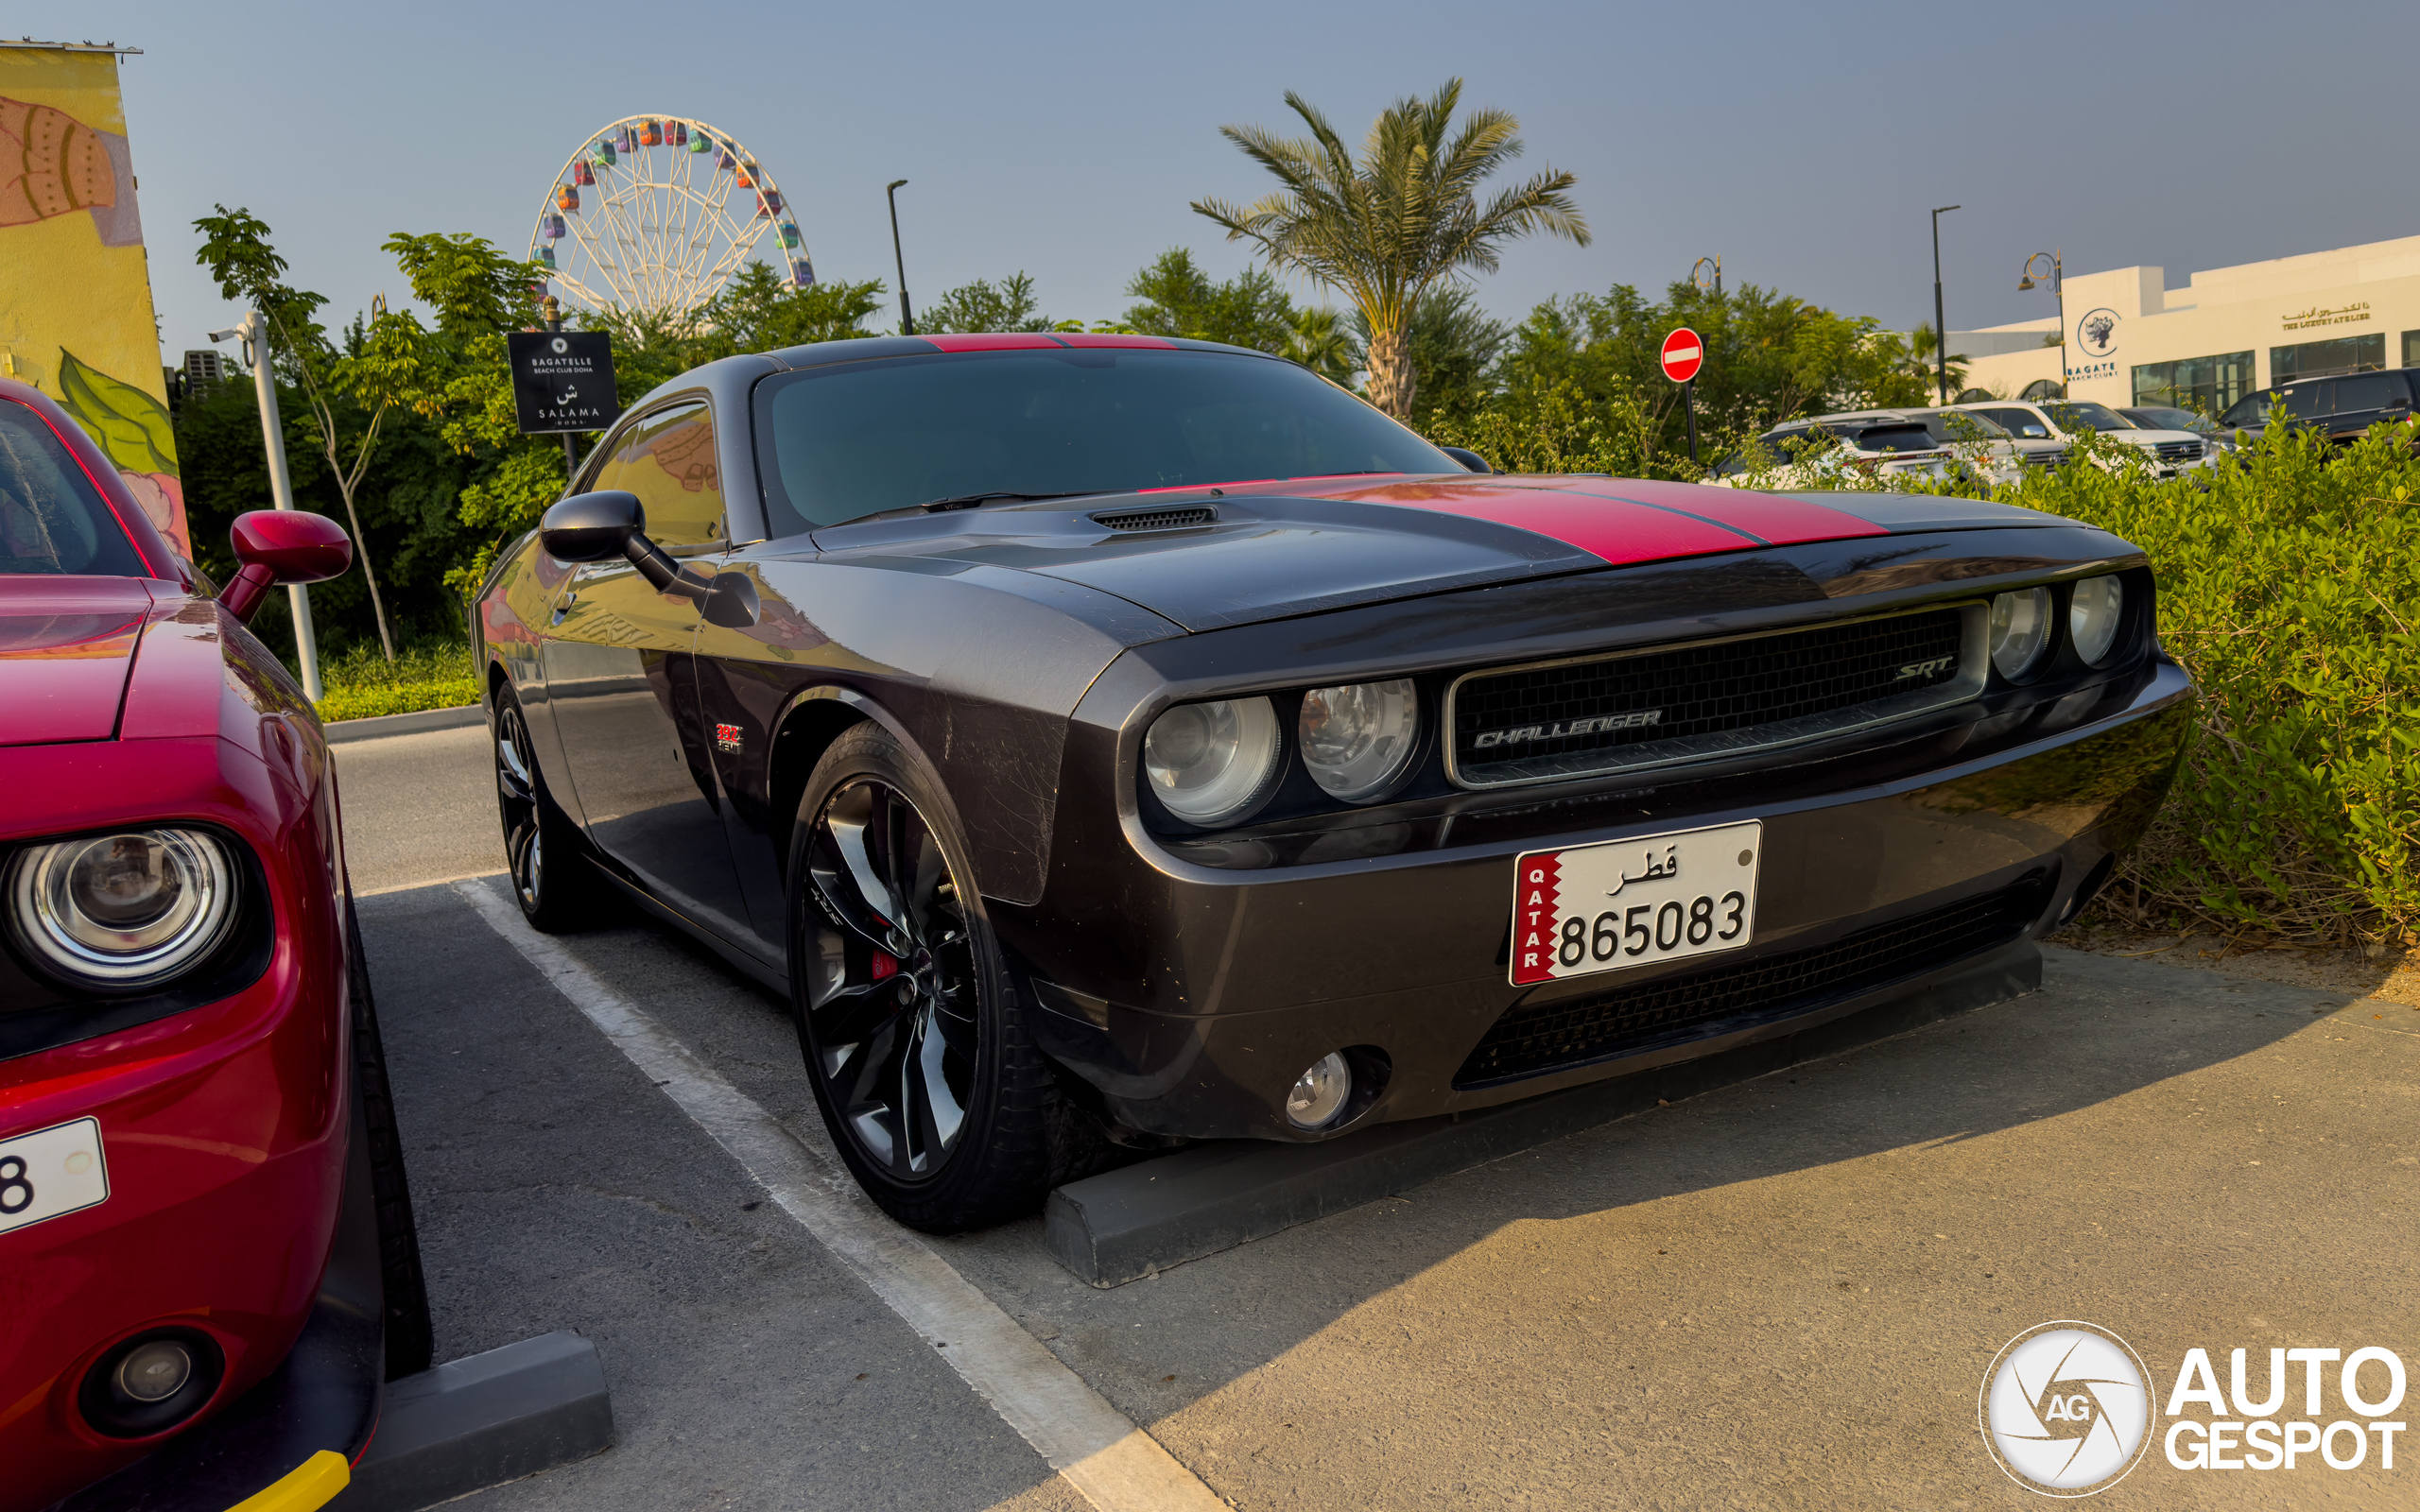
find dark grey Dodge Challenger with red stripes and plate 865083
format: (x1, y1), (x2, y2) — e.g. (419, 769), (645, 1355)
(475, 332), (2192, 1228)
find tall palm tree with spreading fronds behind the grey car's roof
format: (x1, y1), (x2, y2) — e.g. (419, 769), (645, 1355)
(1193, 79), (1587, 421)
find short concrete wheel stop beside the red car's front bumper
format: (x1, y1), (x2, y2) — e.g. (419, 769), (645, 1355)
(341, 1331), (613, 1512)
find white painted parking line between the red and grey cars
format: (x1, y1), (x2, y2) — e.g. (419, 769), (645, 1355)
(453, 881), (1227, 1512)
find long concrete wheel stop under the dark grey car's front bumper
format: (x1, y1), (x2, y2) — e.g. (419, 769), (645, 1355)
(1043, 943), (2043, 1287)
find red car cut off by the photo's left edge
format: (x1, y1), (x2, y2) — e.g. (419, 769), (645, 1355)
(0, 380), (428, 1512)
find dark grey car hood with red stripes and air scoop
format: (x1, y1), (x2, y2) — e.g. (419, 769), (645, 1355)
(816, 474), (2049, 631)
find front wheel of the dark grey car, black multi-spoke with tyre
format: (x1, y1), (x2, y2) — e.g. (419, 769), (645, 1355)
(791, 723), (1072, 1234)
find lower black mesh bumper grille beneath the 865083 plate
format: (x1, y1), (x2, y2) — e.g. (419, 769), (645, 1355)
(1455, 873), (2049, 1089)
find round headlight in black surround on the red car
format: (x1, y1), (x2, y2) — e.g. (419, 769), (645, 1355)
(8, 830), (237, 992)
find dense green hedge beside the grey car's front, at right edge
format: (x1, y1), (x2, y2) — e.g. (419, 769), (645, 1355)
(1964, 423), (2420, 941)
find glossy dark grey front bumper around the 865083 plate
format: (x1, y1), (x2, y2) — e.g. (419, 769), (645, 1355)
(994, 661), (2192, 1142)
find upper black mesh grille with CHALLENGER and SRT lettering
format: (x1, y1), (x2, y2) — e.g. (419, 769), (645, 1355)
(1447, 608), (1982, 786)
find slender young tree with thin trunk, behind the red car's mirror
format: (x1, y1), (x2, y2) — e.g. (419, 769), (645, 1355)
(194, 206), (426, 661)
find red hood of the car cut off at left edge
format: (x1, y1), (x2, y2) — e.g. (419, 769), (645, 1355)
(0, 576), (152, 745)
